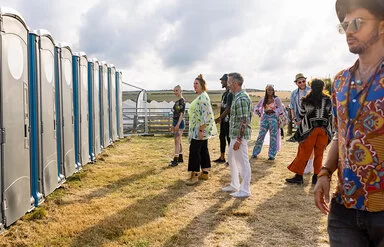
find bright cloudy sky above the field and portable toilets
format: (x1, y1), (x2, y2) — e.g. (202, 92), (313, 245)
(0, 0), (357, 90)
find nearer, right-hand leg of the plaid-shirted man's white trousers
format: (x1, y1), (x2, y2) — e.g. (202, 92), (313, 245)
(234, 138), (251, 194)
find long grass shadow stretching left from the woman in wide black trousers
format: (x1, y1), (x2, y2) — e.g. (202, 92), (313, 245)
(70, 180), (200, 246)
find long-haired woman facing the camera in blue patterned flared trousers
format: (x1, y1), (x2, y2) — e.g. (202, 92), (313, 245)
(252, 84), (285, 160)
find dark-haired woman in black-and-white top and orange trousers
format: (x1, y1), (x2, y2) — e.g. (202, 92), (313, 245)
(286, 79), (332, 184)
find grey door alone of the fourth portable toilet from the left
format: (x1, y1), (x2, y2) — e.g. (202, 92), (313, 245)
(79, 52), (90, 166)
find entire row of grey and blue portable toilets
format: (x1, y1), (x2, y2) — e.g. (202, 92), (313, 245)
(0, 8), (123, 230)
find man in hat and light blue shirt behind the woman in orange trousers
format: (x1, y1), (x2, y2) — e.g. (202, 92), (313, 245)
(289, 73), (311, 127)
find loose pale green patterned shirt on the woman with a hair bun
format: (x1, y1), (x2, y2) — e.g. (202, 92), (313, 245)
(188, 92), (217, 141)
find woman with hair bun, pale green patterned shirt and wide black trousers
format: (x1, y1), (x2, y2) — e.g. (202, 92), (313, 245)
(186, 74), (217, 185)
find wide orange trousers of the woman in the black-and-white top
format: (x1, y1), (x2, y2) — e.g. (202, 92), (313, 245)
(288, 127), (328, 175)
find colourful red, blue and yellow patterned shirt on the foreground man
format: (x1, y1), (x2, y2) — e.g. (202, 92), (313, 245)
(332, 58), (384, 212)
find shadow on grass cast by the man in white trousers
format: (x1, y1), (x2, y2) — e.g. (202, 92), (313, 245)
(162, 191), (242, 247)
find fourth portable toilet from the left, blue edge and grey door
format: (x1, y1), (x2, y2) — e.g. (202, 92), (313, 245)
(72, 52), (90, 169)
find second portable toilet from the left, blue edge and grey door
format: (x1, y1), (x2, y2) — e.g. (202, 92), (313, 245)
(28, 30), (63, 206)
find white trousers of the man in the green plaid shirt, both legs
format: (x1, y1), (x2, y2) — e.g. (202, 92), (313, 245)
(228, 138), (251, 194)
